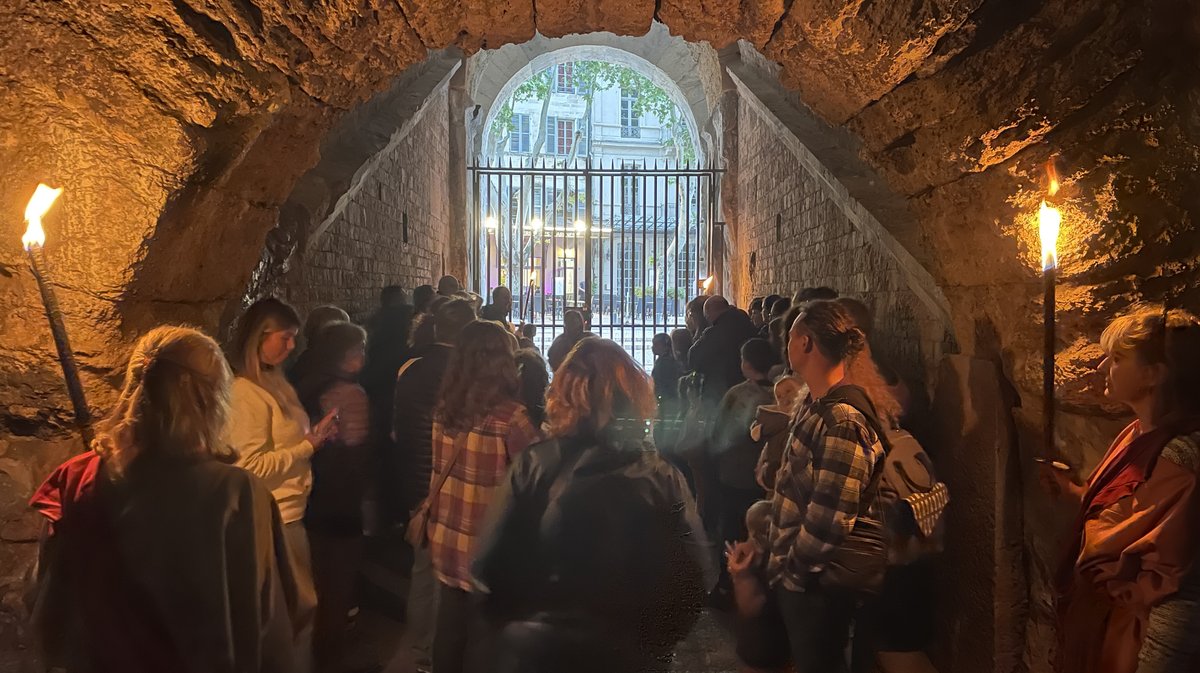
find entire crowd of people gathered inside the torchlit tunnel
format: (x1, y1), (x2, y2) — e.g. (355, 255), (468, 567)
(23, 276), (1200, 673)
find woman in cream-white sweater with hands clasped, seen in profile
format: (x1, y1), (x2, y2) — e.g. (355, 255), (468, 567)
(229, 298), (337, 671)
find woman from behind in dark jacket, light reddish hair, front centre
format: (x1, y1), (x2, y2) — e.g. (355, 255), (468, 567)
(474, 337), (713, 673)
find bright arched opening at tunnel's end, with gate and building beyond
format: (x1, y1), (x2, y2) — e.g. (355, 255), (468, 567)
(468, 41), (721, 362)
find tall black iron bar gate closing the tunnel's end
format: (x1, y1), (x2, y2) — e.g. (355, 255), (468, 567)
(470, 158), (720, 368)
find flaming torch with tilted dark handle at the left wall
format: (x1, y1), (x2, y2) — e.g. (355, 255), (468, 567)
(20, 184), (92, 449)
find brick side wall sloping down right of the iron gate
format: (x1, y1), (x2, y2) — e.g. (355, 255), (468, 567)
(731, 91), (946, 387)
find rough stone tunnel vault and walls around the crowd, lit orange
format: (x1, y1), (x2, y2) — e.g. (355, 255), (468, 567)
(0, 0), (1200, 673)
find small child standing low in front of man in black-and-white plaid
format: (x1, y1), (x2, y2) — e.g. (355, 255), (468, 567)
(725, 500), (790, 672)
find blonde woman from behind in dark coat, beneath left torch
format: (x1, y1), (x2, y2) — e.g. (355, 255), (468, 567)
(31, 328), (296, 673)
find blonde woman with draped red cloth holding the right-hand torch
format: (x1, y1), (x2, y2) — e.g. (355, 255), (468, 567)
(1039, 307), (1200, 673)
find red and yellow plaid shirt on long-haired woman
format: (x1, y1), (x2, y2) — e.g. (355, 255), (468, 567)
(430, 402), (541, 591)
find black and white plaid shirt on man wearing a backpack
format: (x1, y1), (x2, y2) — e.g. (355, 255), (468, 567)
(767, 393), (883, 591)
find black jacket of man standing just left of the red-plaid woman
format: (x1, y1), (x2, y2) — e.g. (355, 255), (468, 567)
(383, 343), (454, 522)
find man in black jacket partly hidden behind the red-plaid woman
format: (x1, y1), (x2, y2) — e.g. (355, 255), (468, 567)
(388, 299), (475, 663)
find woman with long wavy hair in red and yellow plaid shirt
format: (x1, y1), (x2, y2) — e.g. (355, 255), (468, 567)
(428, 320), (541, 673)
